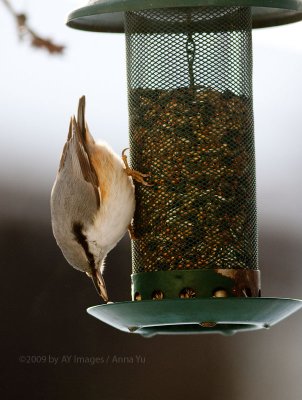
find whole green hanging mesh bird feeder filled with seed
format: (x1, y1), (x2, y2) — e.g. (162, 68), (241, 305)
(67, 0), (302, 336)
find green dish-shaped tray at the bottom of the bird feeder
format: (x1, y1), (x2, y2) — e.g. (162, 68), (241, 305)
(87, 297), (302, 337)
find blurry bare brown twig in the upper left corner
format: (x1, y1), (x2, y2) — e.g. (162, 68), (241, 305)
(1, 0), (65, 54)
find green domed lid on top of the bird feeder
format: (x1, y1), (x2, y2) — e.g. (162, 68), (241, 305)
(67, 0), (302, 32)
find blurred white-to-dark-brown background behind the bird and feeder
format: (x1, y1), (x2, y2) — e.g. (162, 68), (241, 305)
(0, 0), (302, 400)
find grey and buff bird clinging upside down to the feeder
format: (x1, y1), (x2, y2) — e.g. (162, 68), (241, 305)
(50, 96), (152, 303)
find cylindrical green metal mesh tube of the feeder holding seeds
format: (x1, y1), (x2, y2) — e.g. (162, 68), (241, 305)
(125, 7), (258, 273)
